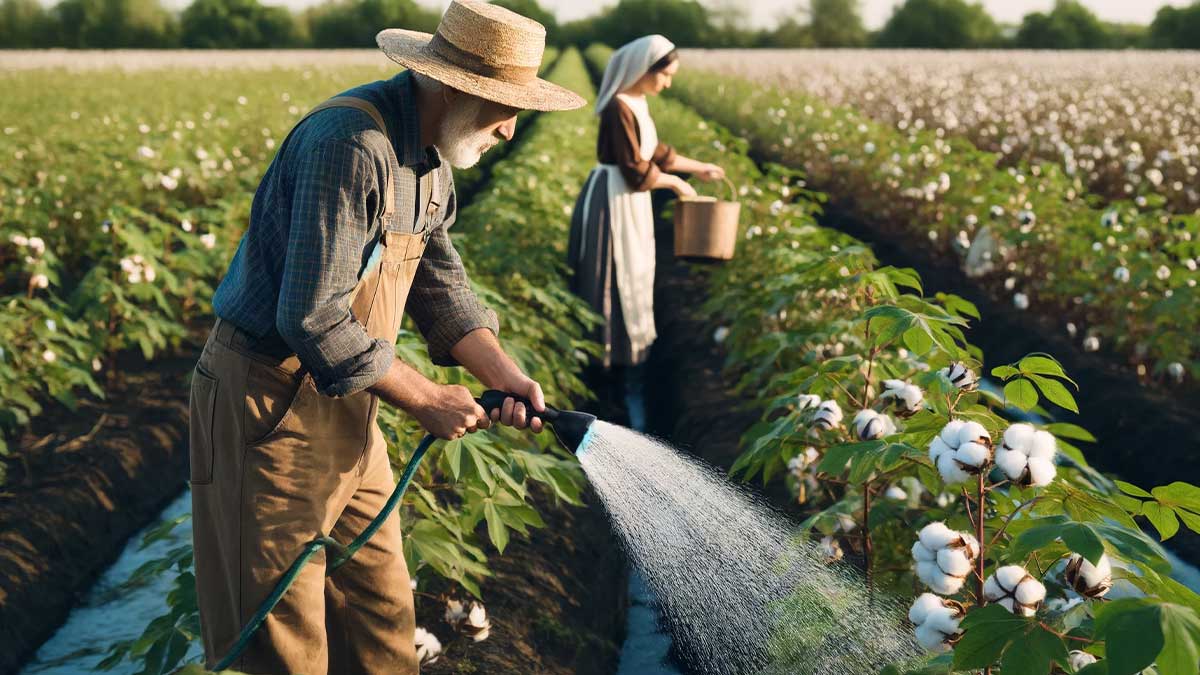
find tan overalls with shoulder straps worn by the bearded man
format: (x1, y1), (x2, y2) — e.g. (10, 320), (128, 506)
(191, 97), (440, 675)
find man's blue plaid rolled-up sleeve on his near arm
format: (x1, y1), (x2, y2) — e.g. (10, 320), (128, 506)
(275, 139), (395, 398)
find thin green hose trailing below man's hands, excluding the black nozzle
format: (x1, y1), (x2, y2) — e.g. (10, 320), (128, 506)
(212, 434), (437, 671)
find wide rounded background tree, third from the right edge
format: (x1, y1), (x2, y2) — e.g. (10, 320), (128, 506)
(876, 0), (1002, 49)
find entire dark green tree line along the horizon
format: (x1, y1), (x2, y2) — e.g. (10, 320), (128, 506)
(0, 0), (1200, 49)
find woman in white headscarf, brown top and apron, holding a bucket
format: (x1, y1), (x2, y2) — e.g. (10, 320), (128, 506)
(568, 35), (725, 386)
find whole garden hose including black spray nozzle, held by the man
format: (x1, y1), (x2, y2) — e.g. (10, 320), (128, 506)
(212, 389), (596, 671)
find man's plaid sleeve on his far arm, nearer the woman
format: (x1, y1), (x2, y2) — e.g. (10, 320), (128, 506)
(407, 186), (500, 365)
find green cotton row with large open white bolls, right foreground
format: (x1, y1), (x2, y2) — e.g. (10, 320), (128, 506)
(588, 48), (1200, 675)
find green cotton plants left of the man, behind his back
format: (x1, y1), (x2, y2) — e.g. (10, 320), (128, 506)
(0, 45), (556, 468)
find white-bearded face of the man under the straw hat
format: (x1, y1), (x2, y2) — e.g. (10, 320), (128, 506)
(434, 92), (518, 168)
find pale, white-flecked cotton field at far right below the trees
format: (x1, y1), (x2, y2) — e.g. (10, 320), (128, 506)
(684, 50), (1200, 214)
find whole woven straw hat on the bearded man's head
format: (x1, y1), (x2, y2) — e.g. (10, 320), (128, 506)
(376, 0), (586, 110)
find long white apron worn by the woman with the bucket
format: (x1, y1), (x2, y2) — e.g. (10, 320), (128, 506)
(580, 94), (659, 354)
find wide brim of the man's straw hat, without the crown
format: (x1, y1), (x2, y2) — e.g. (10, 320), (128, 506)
(376, 28), (587, 112)
